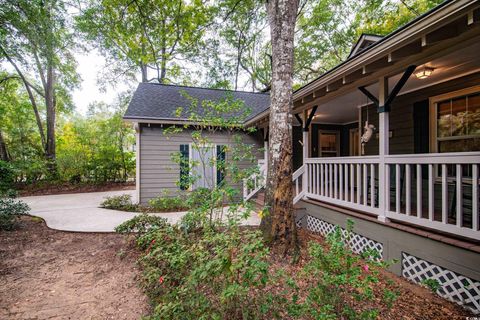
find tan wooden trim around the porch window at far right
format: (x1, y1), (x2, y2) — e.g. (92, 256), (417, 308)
(429, 85), (480, 153)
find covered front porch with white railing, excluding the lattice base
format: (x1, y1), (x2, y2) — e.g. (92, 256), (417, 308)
(245, 2), (480, 242)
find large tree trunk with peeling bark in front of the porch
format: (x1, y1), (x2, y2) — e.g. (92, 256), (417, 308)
(261, 0), (298, 254)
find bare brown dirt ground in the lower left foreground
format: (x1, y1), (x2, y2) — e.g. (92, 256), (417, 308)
(0, 217), (149, 320)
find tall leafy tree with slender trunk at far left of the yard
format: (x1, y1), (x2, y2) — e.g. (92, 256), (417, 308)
(0, 0), (78, 174)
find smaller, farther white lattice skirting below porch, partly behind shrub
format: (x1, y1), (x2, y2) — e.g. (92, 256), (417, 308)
(306, 215), (383, 258)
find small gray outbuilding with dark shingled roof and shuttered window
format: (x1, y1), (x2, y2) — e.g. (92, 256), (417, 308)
(124, 83), (270, 204)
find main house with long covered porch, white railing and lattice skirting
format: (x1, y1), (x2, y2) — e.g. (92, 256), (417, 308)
(126, 0), (480, 313)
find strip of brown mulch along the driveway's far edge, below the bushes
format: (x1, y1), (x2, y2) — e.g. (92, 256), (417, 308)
(17, 182), (135, 197)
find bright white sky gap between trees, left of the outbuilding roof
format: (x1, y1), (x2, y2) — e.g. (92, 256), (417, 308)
(72, 50), (133, 114)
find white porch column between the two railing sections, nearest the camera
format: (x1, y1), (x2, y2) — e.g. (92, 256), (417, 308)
(378, 77), (390, 222)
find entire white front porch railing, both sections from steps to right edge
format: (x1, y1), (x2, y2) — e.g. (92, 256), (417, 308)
(302, 152), (480, 240)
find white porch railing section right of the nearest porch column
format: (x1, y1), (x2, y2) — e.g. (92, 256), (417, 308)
(385, 152), (480, 240)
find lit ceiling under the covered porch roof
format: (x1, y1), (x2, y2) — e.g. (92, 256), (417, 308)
(308, 41), (480, 124)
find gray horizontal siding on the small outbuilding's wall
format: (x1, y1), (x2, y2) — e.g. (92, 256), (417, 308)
(139, 125), (263, 204)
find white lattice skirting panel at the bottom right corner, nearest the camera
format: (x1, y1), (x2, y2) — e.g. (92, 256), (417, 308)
(402, 252), (480, 314)
